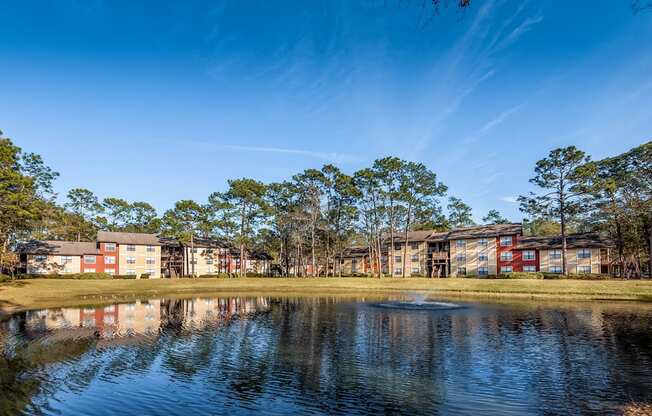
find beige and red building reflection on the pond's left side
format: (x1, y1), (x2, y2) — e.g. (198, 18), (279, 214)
(9, 297), (270, 339)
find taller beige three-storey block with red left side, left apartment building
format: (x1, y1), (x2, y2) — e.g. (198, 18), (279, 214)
(97, 231), (161, 279)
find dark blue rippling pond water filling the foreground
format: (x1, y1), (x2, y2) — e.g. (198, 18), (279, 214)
(0, 297), (652, 415)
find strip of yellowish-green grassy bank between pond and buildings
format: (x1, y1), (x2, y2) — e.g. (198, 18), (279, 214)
(0, 278), (652, 312)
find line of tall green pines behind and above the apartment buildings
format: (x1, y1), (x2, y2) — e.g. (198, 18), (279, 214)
(0, 129), (652, 277)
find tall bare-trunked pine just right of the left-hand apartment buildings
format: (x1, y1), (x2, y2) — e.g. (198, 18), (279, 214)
(214, 178), (268, 277)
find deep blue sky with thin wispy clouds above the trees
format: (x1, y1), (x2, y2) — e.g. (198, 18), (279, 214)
(0, 0), (652, 220)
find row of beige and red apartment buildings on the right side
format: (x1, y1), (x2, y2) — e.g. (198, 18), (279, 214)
(342, 223), (612, 277)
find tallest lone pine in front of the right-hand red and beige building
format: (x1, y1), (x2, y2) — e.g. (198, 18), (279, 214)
(519, 146), (591, 275)
